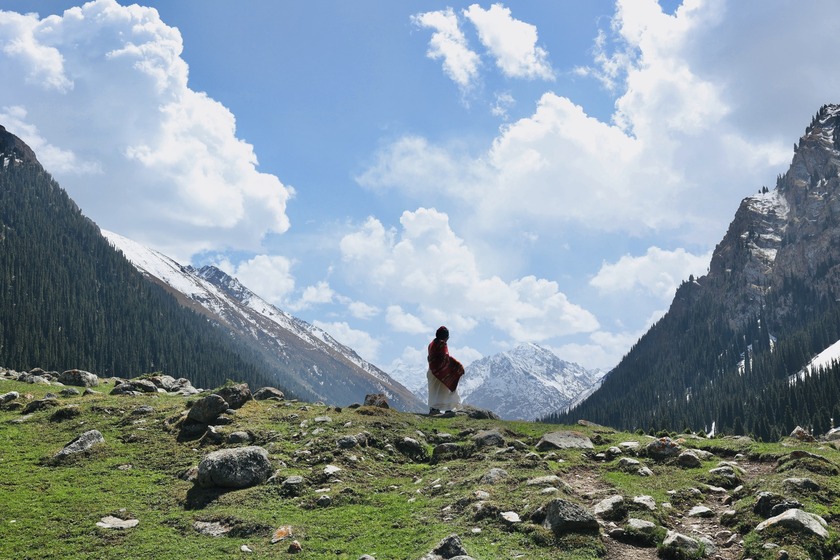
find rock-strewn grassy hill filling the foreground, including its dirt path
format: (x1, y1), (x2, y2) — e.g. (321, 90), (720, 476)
(0, 370), (840, 560)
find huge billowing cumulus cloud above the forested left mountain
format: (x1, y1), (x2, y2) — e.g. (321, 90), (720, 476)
(0, 0), (293, 261)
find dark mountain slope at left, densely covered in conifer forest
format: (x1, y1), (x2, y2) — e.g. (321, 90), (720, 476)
(0, 127), (286, 389)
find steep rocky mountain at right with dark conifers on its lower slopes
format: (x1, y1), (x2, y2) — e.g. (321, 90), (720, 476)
(549, 105), (840, 439)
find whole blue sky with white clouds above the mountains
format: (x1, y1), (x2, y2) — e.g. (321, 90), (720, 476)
(0, 0), (840, 380)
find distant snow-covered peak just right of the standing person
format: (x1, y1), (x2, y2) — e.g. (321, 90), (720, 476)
(458, 344), (603, 420)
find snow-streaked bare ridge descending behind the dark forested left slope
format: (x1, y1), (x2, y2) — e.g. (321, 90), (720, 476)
(102, 231), (425, 410)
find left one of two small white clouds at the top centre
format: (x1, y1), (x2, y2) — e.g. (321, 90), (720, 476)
(411, 8), (480, 93)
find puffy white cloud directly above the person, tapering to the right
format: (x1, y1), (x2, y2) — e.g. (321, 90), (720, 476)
(341, 208), (598, 341)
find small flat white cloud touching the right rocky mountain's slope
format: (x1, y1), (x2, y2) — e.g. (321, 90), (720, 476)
(589, 247), (712, 301)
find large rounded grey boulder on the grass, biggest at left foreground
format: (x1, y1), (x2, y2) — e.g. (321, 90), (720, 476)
(196, 446), (272, 488)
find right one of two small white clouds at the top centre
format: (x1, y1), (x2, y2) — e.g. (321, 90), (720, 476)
(464, 4), (554, 80)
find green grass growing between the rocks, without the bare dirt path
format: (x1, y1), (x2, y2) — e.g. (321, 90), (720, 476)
(0, 380), (840, 560)
